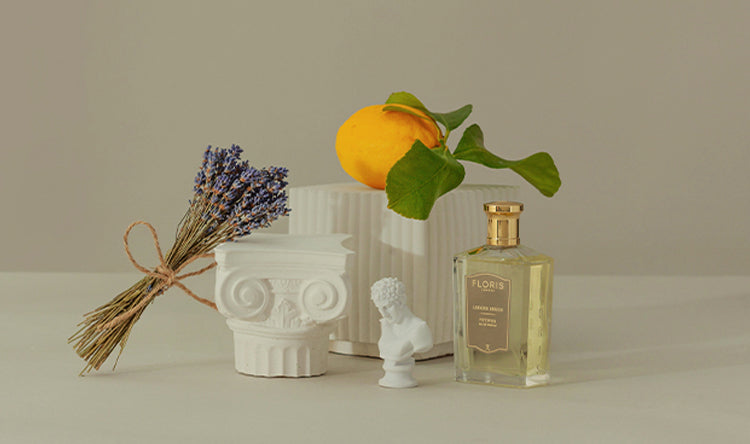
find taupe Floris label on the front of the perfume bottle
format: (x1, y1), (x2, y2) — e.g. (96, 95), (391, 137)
(466, 273), (510, 353)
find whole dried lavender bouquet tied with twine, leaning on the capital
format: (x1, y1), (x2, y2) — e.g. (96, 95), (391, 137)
(68, 145), (289, 374)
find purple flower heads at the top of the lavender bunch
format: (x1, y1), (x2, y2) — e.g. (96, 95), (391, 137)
(191, 145), (290, 239)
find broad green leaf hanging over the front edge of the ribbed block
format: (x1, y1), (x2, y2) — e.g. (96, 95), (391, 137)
(385, 140), (465, 220)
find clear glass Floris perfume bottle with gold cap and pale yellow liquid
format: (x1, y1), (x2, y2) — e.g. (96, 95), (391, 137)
(453, 202), (553, 388)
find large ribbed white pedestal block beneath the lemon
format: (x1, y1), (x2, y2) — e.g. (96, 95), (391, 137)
(289, 183), (518, 359)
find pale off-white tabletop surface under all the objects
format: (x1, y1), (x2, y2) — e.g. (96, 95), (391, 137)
(0, 273), (750, 443)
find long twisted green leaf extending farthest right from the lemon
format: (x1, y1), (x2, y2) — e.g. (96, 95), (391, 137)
(453, 124), (561, 197)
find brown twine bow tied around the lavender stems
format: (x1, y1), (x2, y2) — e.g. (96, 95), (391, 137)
(96, 220), (216, 330)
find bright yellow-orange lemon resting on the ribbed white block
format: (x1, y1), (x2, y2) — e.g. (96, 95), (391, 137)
(336, 105), (441, 190)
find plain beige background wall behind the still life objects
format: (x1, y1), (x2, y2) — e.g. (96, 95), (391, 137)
(0, 1), (750, 274)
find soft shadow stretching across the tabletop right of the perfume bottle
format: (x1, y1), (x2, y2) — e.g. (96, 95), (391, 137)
(551, 294), (750, 384)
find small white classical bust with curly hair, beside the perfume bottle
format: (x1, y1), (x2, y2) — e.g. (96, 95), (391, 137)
(370, 278), (432, 388)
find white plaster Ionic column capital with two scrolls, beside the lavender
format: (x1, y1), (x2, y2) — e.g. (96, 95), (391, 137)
(215, 234), (352, 377)
